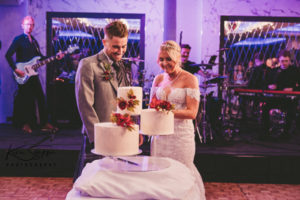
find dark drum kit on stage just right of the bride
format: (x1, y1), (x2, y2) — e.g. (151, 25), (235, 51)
(194, 56), (247, 143)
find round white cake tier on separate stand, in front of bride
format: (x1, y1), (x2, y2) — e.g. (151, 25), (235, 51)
(140, 108), (174, 135)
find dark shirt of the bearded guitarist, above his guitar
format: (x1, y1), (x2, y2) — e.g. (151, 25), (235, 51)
(5, 34), (44, 70)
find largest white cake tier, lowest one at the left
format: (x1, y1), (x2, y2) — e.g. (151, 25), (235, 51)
(94, 122), (139, 156)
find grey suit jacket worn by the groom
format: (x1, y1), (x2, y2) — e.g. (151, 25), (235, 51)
(75, 50), (131, 142)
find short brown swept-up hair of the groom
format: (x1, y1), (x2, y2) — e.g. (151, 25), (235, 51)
(104, 20), (128, 39)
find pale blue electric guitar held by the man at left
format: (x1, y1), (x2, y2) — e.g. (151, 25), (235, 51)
(13, 46), (79, 85)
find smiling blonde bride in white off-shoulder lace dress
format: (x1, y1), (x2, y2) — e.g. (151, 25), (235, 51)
(150, 40), (205, 199)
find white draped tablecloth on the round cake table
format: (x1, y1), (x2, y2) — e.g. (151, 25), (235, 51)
(66, 156), (200, 200)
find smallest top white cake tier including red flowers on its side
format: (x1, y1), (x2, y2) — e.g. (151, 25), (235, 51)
(117, 87), (143, 115)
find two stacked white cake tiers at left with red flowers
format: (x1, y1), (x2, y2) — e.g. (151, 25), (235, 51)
(94, 87), (143, 156)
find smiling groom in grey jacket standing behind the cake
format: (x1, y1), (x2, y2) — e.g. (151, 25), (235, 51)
(75, 21), (131, 178)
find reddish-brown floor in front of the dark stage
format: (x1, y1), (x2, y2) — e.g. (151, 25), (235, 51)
(0, 177), (300, 200)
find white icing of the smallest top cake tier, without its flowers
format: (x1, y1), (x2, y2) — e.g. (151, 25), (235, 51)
(117, 87), (143, 115)
